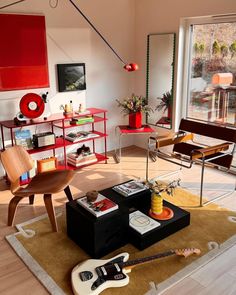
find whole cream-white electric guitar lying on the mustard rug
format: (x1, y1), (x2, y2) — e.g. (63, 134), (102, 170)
(71, 248), (201, 295)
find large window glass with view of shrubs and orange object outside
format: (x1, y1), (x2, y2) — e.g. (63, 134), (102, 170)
(186, 21), (236, 126)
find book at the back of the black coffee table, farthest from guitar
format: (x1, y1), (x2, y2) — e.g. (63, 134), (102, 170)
(112, 180), (148, 197)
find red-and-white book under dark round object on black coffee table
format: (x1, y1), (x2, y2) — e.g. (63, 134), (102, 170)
(77, 193), (119, 217)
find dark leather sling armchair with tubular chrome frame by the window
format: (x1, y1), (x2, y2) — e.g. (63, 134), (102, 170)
(146, 119), (236, 206)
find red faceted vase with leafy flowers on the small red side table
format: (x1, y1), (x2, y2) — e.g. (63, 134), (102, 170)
(116, 94), (152, 129)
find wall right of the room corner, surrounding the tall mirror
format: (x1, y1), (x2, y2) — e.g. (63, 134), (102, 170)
(135, 0), (236, 146)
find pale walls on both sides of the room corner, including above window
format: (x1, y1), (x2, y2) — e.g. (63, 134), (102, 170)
(0, 0), (236, 173)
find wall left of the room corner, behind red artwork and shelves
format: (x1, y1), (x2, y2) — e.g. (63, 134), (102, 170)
(0, 0), (135, 176)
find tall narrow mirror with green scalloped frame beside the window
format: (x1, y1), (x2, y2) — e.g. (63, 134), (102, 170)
(146, 33), (175, 129)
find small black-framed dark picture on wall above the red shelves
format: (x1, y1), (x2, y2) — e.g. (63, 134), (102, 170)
(57, 63), (86, 92)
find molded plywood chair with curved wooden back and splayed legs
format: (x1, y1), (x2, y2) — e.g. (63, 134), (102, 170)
(0, 145), (74, 231)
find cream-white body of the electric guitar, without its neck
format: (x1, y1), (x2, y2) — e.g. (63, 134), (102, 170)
(71, 253), (129, 295)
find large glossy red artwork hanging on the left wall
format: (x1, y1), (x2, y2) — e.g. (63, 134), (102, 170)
(0, 14), (49, 91)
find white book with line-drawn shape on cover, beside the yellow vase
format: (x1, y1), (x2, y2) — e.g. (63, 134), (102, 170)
(129, 210), (161, 235)
